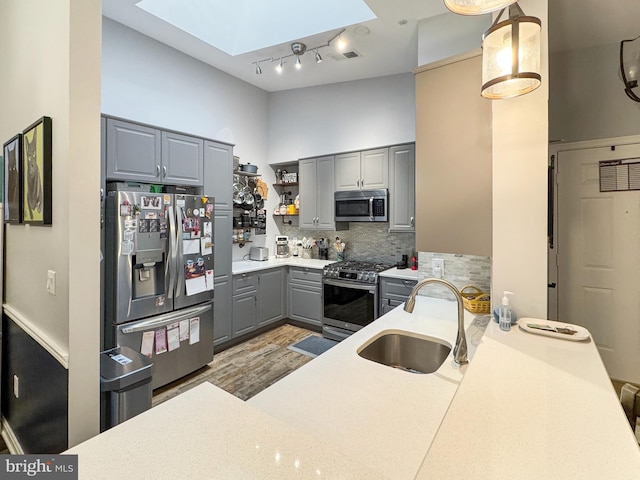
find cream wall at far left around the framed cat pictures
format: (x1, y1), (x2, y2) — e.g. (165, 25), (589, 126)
(0, 0), (101, 445)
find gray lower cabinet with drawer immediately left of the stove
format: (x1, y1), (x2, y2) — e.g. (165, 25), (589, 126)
(287, 267), (322, 326)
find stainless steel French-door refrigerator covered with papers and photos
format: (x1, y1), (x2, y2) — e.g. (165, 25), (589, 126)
(104, 188), (214, 388)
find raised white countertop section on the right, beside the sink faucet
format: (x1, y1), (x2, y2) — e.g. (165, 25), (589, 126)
(416, 316), (640, 480)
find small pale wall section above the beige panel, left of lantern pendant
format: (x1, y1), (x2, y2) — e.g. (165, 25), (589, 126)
(418, 12), (492, 66)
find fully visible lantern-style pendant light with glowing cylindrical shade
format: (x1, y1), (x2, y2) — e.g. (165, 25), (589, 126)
(481, 3), (542, 99)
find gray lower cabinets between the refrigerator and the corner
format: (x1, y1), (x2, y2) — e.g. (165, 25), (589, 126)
(232, 267), (285, 336)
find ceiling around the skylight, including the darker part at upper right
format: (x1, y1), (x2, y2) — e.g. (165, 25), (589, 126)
(102, 0), (640, 91)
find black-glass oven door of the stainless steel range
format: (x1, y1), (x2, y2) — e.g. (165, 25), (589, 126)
(322, 278), (378, 337)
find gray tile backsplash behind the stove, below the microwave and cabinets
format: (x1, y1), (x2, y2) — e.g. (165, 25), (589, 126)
(280, 222), (416, 264)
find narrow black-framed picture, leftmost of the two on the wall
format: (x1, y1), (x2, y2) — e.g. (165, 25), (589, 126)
(2, 133), (22, 223)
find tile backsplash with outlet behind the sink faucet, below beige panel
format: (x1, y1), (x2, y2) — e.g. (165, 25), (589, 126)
(418, 252), (491, 299)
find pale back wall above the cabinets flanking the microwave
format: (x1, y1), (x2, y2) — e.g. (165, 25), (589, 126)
(268, 73), (416, 163)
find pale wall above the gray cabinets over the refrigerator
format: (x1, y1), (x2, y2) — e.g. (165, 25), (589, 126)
(102, 18), (277, 259)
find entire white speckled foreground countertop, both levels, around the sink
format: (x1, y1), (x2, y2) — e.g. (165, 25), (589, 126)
(67, 296), (640, 480)
